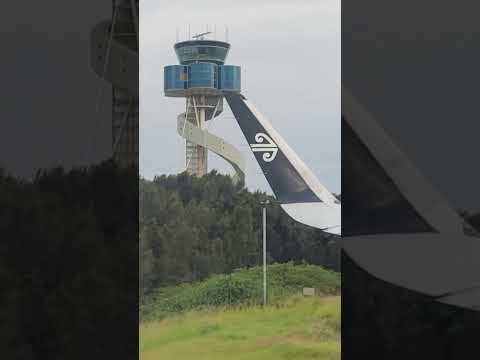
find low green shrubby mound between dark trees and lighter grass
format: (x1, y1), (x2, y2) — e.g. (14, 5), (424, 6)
(140, 263), (340, 321)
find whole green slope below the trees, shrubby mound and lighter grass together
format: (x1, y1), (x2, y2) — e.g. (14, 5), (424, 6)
(140, 263), (340, 360)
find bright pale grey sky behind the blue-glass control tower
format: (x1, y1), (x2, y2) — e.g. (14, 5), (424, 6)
(140, 0), (341, 192)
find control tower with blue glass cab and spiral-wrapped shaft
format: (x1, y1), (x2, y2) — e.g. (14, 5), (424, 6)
(164, 33), (248, 181)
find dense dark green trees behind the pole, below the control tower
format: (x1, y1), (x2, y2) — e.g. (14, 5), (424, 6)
(139, 171), (339, 299)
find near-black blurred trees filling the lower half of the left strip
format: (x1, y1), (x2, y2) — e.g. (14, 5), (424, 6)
(0, 161), (138, 360)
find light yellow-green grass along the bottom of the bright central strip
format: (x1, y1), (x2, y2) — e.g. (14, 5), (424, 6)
(140, 295), (340, 360)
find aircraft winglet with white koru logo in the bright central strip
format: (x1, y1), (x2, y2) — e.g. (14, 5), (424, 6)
(224, 93), (341, 234)
